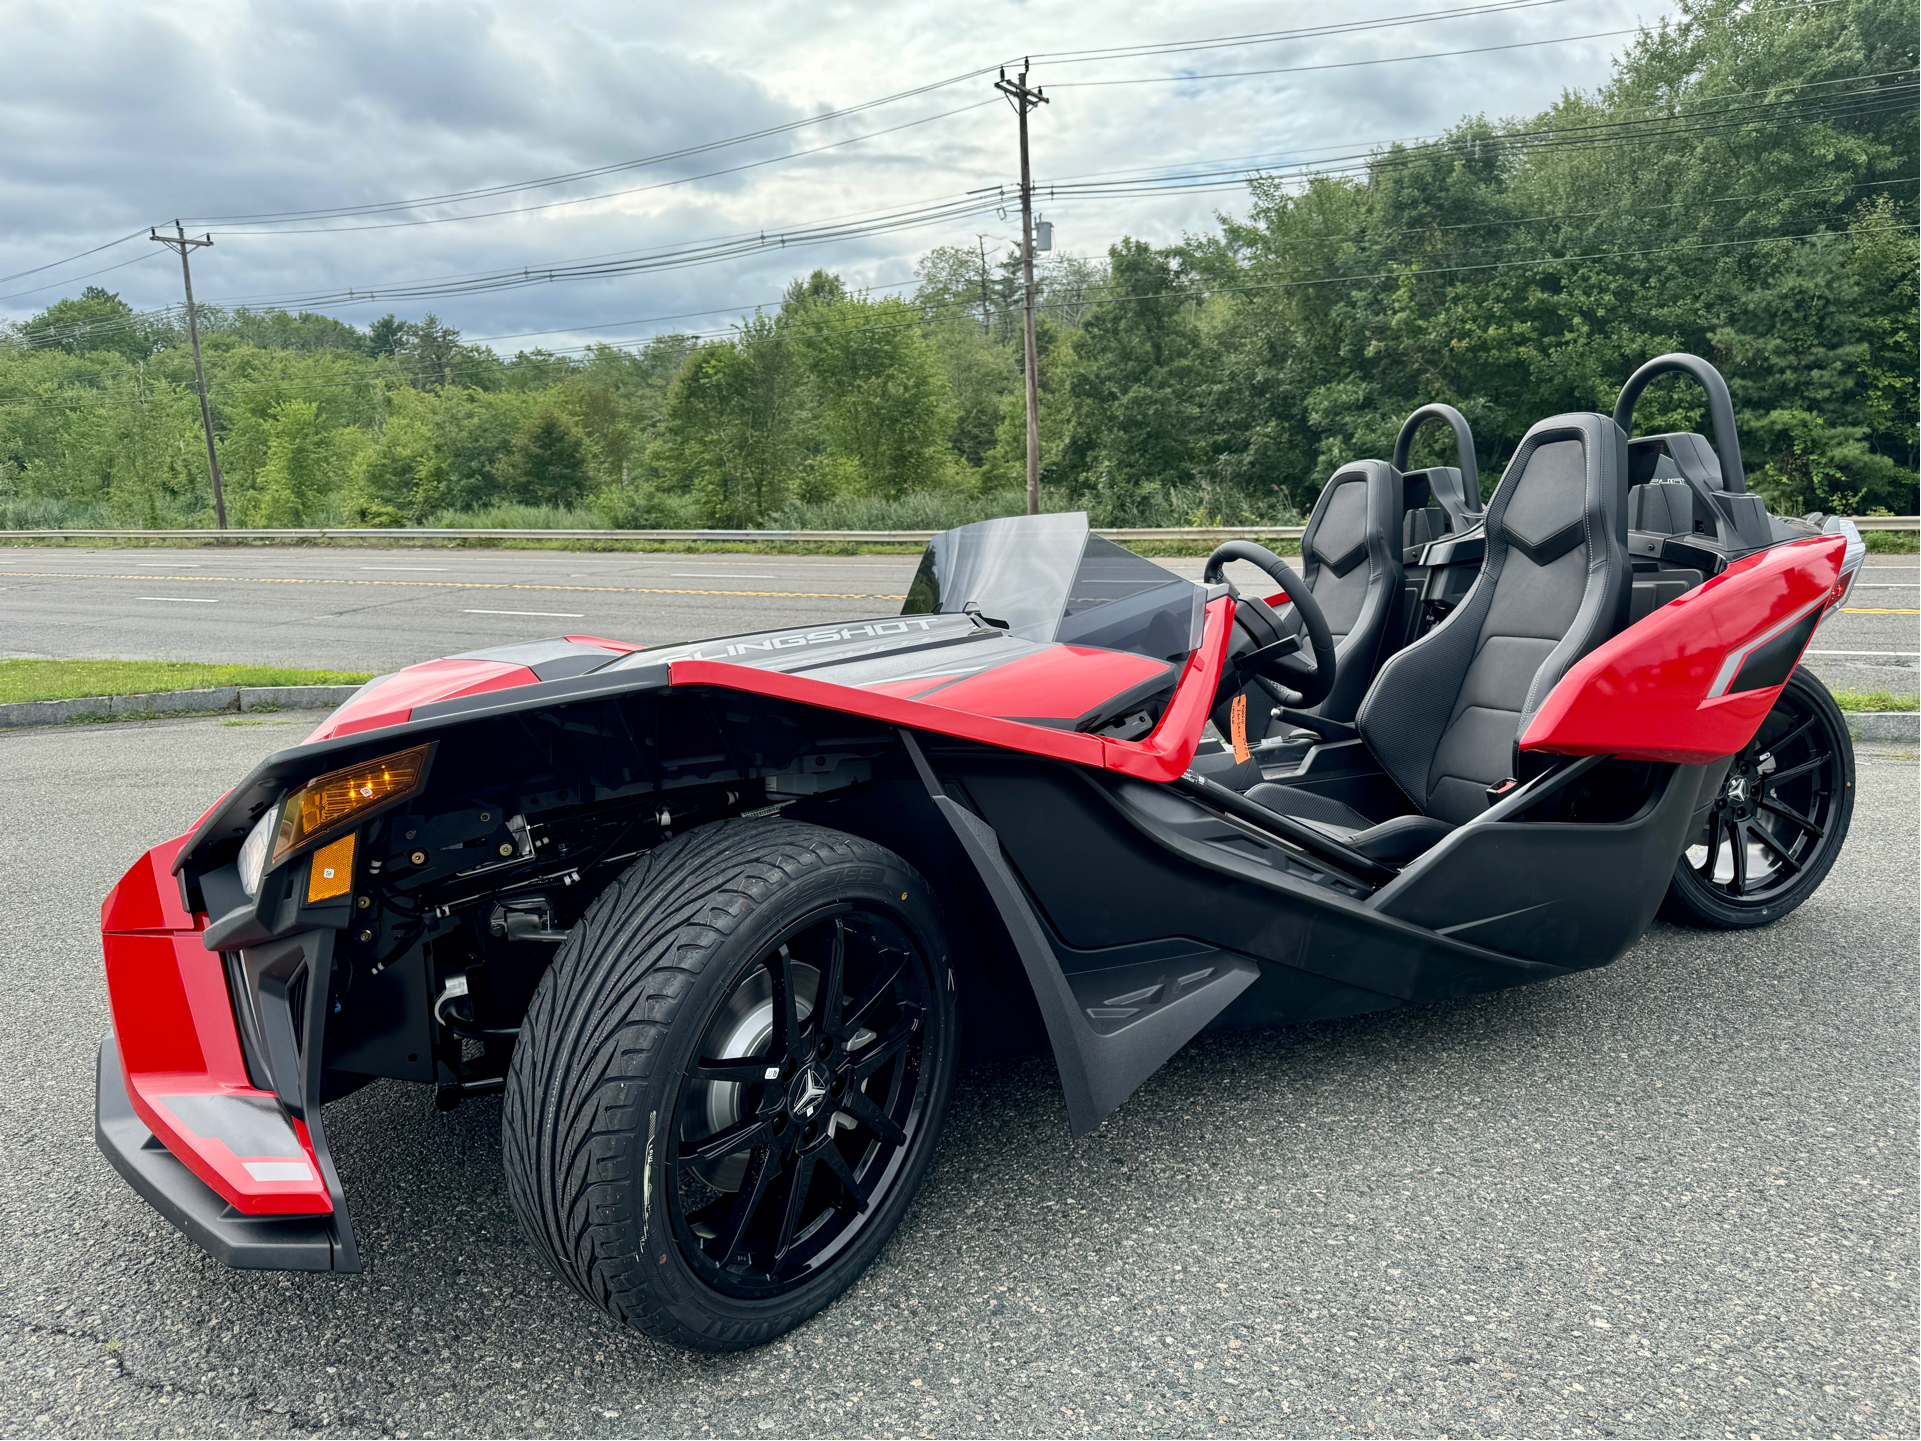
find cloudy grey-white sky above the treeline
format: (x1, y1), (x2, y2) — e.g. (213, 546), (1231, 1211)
(0, 0), (1673, 354)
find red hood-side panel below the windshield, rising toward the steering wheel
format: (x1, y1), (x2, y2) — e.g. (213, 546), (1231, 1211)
(669, 598), (1233, 782)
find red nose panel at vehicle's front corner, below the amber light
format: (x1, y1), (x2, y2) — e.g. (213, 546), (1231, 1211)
(100, 836), (332, 1216)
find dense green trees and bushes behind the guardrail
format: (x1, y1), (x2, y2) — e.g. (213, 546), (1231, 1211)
(0, 0), (1921, 526)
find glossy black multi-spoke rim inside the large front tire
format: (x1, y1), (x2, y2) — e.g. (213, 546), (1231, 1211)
(667, 903), (937, 1297)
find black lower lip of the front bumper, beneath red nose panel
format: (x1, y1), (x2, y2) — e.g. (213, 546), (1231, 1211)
(94, 1039), (346, 1270)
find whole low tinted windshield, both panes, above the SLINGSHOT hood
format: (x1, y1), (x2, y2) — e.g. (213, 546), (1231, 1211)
(901, 511), (1206, 661)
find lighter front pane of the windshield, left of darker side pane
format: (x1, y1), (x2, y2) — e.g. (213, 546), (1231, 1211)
(901, 511), (1087, 640)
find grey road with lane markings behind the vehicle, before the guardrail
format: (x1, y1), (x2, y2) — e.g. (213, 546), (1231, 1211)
(0, 546), (1921, 694)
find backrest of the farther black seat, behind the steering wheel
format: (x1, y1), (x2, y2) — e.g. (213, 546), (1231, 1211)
(1301, 461), (1402, 721)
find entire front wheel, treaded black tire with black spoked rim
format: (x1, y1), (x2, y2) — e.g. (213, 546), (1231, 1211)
(501, 818), (959, 1351)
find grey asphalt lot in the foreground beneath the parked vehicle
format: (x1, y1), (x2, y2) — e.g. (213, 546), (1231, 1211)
(0, 718), (1921, 1437)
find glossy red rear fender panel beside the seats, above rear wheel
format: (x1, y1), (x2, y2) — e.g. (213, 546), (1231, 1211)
(1521, 536), (1846, 765)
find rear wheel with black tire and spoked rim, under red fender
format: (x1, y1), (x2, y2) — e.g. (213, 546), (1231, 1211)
(1662, 667), (1854, 930)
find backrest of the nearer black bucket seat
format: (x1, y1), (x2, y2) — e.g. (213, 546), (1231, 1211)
(1358, 413), (1631, 824)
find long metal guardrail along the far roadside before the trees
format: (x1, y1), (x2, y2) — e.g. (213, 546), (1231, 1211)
(0, 515), (1921, 546)
